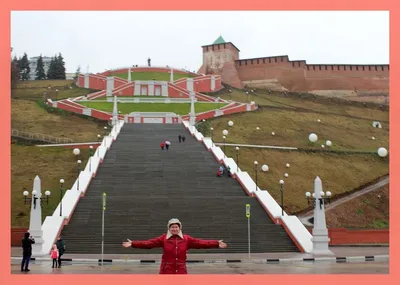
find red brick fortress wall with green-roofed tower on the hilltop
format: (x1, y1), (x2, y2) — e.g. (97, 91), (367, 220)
(199, 36), (389, 96)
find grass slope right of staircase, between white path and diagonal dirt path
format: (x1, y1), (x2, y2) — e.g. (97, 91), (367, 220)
(222, 146), (389, 213)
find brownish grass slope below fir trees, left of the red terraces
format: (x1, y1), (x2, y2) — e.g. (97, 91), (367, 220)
(11, 80), (105, 142)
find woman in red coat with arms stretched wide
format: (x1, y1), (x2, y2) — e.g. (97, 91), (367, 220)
(122, 219), (227, 274)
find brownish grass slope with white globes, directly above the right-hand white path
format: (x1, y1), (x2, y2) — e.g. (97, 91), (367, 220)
(211, 108), (389, 152)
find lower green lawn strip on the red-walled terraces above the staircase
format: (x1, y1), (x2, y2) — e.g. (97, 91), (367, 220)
(80, 102), (226, 115)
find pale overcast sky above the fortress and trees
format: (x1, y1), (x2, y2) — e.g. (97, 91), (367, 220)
(11, 11), (389, 73)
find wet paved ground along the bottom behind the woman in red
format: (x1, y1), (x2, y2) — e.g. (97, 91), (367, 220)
(11, 260), (389, 274)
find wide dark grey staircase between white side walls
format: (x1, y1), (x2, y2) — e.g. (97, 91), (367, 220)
(58, 124), (298, 254)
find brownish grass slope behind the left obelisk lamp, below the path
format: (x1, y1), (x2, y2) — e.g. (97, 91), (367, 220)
(11, 145), (93, 227)
